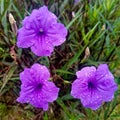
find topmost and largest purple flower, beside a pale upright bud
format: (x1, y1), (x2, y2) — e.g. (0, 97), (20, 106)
(17, 6), (67, 56)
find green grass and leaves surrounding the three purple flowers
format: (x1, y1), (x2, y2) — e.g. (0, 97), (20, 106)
(0, 0), (120, 120)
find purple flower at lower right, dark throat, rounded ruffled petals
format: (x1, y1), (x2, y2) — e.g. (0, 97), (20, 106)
(71, 64), (117, 110)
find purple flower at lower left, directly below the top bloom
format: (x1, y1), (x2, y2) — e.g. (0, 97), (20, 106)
(17, 63), (59, 111)
